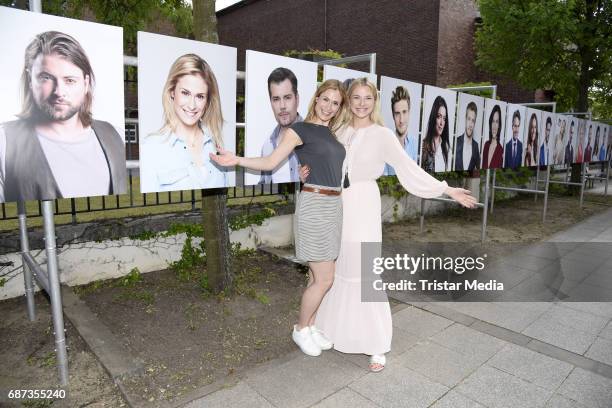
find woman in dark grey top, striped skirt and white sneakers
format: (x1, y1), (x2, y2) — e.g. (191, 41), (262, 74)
(210, 80), (347, 356)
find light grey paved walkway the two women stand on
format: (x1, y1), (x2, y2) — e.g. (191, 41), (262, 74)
(186, 209), (612, 408)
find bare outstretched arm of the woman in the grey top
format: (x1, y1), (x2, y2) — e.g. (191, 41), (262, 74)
(210, 129), (302, 171)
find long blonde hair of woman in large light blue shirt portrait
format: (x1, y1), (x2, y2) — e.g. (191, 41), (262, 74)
(159, 54), (223, 148)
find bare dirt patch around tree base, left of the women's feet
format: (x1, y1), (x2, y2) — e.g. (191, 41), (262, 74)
(79, 253), (306, 406)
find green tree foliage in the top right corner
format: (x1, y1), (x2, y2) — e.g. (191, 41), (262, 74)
(476, 0), (612, 115)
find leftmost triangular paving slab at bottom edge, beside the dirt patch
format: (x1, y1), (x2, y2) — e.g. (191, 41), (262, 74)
(184, 382), (274, 408)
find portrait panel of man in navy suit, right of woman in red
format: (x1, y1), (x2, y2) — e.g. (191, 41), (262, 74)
(503, 103), (527, 169)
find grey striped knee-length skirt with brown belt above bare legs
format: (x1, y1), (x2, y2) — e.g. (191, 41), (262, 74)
(293, 184), (342, 262)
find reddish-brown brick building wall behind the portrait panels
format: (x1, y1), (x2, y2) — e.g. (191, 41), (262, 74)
(217, 0), (534, 102)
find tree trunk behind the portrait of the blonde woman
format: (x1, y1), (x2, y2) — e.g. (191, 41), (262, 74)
(193, 0), (232, 293)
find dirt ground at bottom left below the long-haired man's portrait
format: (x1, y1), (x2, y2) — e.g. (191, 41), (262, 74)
(0, 293), (126, 408)
